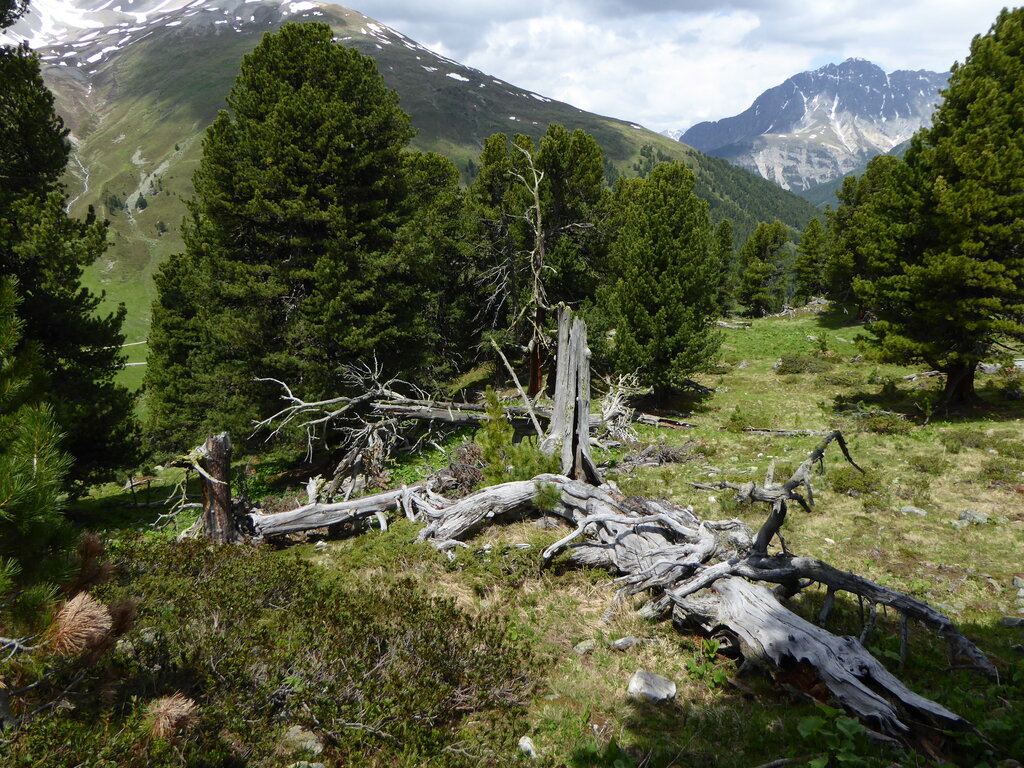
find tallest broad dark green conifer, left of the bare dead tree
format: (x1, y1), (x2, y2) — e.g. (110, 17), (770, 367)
(146, 24), (419, 447)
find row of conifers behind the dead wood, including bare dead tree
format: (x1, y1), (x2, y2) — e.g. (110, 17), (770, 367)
(144, 25), (753, 450)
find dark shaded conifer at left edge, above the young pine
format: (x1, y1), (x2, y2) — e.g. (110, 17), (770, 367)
(0, 31), (136, 489)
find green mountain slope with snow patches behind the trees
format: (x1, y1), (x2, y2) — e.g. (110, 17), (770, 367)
(34, 0), (813, 364)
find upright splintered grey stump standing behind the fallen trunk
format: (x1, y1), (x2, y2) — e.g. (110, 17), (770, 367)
(541, 306), (601, 485)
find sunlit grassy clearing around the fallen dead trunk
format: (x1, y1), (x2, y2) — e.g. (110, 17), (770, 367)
(59, 315), (1024, 768)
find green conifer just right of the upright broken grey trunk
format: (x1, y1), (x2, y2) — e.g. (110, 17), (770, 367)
(600, 163), (720, 397)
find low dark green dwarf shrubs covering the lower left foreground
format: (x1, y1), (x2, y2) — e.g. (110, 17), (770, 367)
(6, 541), (530, 768)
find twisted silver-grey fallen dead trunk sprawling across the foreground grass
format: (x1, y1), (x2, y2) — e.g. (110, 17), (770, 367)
(241, 433), (993, 744)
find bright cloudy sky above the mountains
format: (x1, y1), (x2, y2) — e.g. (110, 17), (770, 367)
(342, 0), (1007, 131)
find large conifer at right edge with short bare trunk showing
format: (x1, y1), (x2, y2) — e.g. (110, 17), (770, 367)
(855, 8), (1024, 404)
